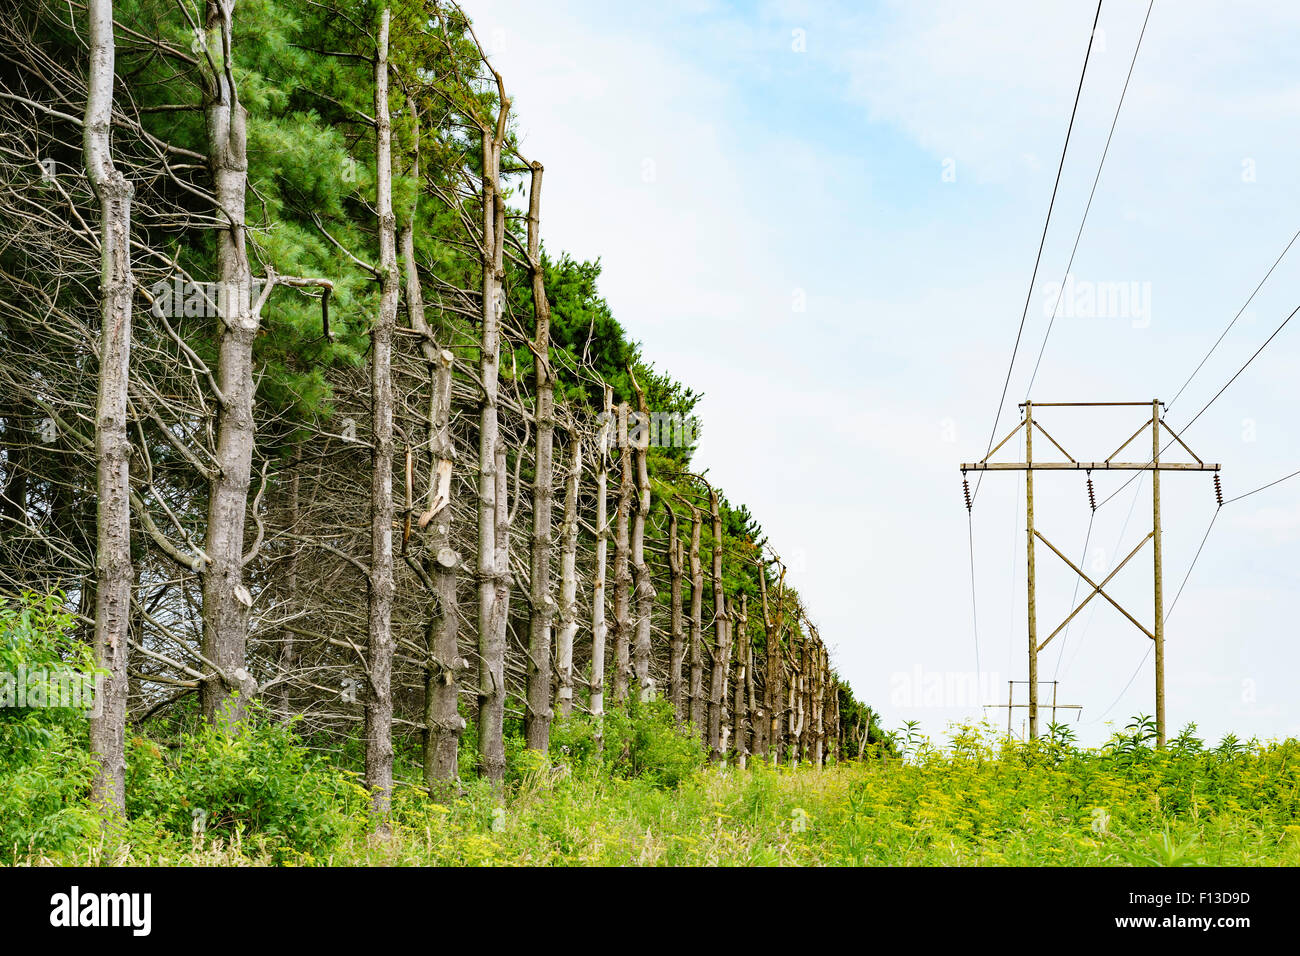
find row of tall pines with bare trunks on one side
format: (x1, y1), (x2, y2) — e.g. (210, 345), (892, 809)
(0, 0), (872, 813)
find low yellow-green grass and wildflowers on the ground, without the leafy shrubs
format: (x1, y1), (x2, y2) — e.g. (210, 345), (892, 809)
(20, 724), (1300, 866)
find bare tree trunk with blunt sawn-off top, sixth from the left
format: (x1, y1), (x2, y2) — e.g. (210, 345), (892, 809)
(524, 163), (555, 752)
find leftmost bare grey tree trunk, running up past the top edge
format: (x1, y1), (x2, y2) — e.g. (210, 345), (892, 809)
(85, 0), (135, 819)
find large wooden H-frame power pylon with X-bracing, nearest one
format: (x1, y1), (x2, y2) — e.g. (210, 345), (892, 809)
(962, 399), (1219, 747)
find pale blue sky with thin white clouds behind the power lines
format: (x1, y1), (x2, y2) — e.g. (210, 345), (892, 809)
(464, 0), (1300, 744)
